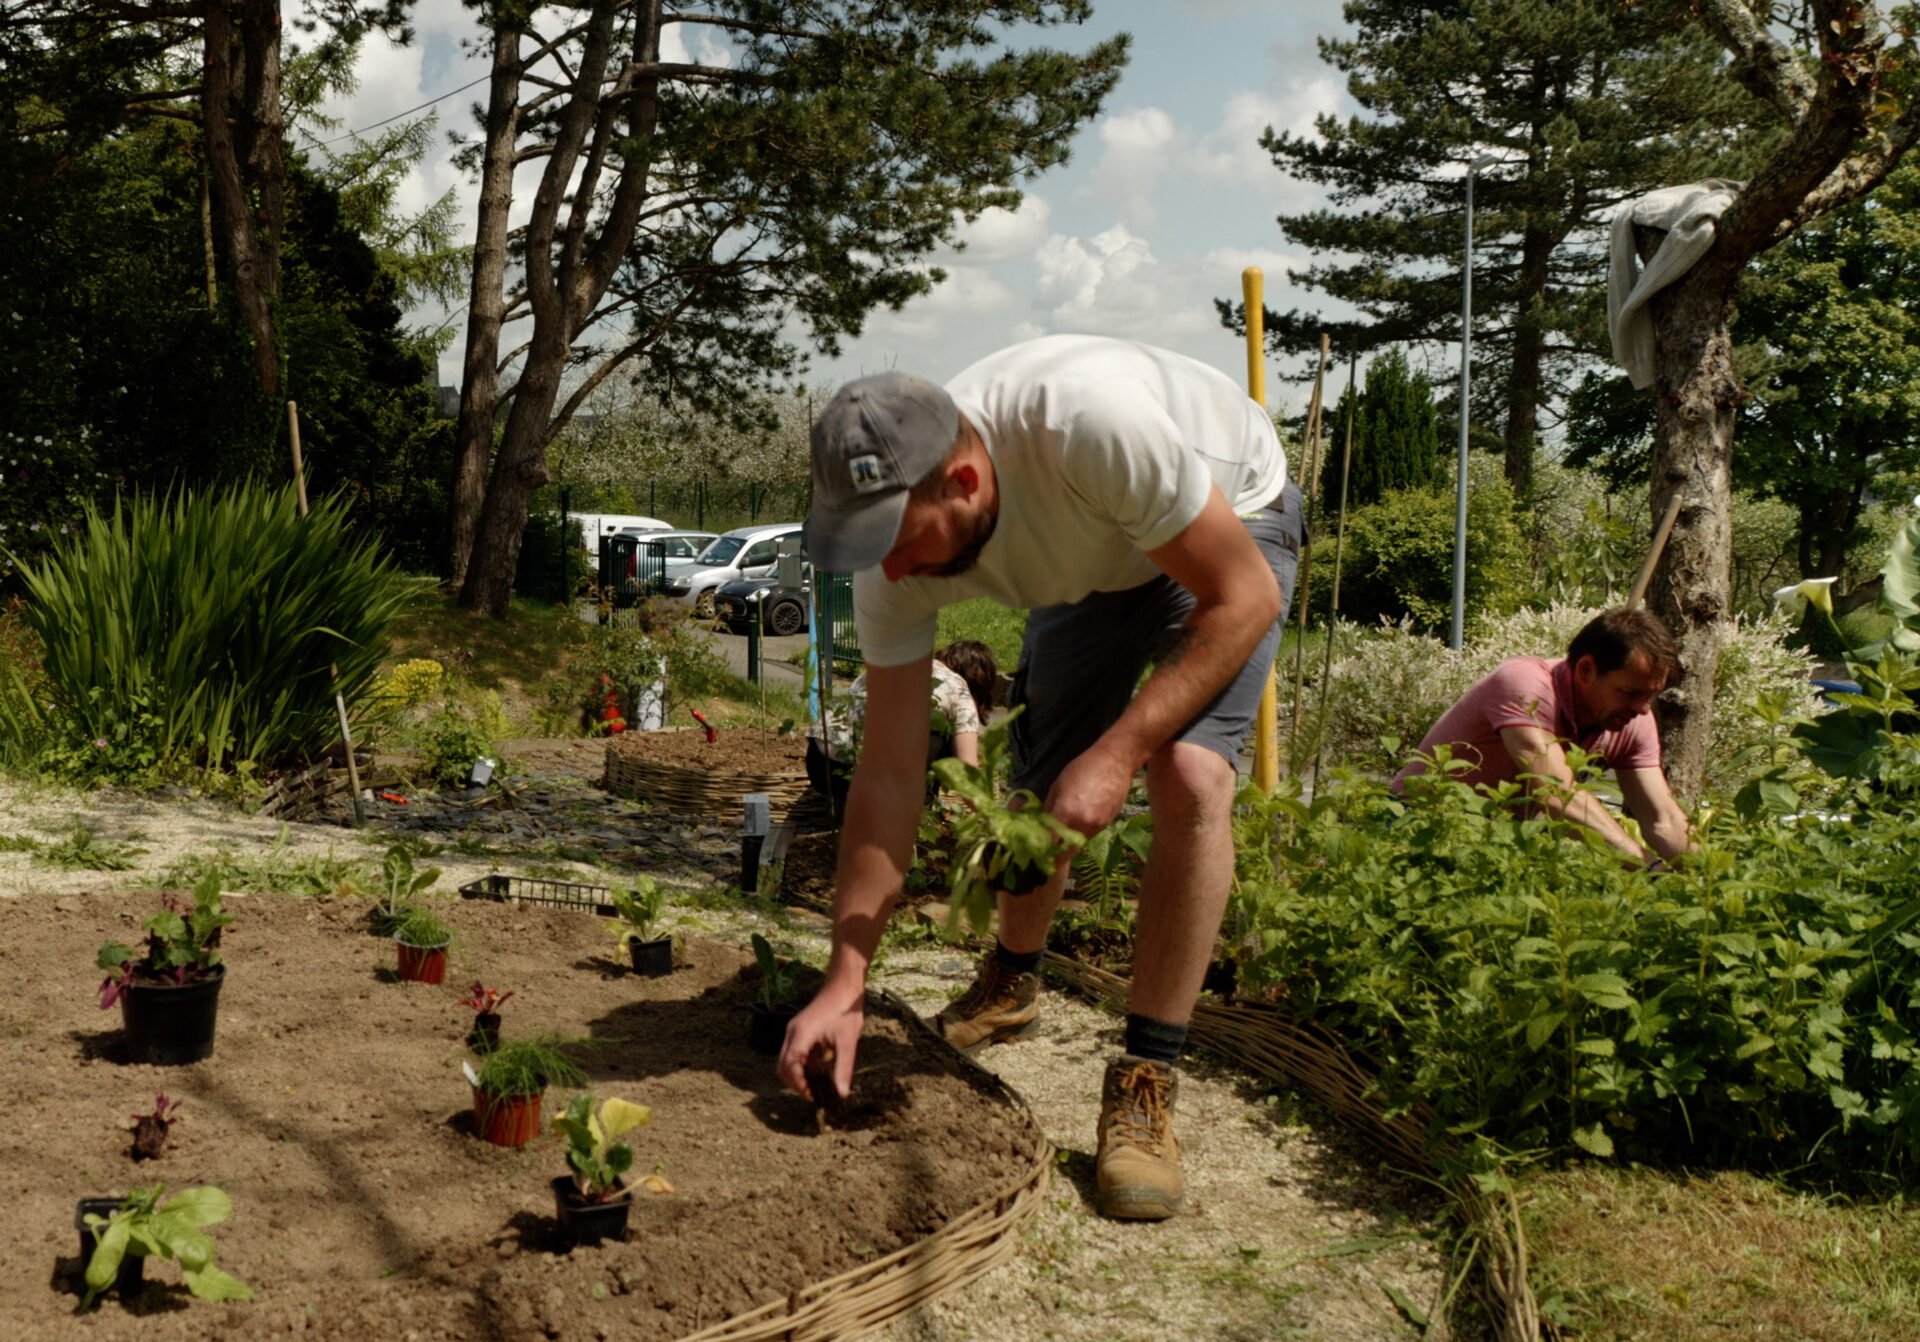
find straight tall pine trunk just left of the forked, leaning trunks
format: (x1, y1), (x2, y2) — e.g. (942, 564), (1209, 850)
(447, 25), (520, 586)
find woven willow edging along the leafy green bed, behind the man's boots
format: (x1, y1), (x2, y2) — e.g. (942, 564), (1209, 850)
(1046, 950), (1540, 1342)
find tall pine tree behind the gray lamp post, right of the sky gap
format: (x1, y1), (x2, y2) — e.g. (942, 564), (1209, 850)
(1221, 0), (1753, 499)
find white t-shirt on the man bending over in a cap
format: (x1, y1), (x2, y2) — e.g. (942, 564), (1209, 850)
(852, 336), (1286, 666)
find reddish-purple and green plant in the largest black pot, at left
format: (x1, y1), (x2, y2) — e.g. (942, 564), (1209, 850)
(96, 872), (234, 1066)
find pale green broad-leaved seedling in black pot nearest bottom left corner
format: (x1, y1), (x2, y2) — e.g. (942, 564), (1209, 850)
(73, 1185), (253, 1309)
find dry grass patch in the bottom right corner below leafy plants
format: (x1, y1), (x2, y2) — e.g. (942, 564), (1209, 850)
(1523, 1165), (1920, 1342)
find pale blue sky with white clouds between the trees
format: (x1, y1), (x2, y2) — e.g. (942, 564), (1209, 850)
(311, 0), (1352, 414)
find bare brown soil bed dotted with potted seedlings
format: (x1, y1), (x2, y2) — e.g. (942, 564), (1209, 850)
(0, 895), (1035, 1342)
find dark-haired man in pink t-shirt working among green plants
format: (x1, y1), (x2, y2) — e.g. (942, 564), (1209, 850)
(1394, 611), (1693, 870)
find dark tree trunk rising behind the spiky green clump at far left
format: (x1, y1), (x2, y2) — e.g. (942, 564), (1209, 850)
(200, 0), (286, 399)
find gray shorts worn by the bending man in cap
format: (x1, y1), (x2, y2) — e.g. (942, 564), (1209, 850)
(1008, 484), (1306, 799)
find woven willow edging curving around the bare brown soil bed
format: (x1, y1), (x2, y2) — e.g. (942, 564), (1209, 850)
(664, 993), (1054, 1342)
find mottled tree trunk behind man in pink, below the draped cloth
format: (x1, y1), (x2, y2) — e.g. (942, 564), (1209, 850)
(1634, 228), (1740, 799)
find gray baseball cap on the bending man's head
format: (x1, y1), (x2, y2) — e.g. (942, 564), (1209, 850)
(806, 372), (960, 574)
